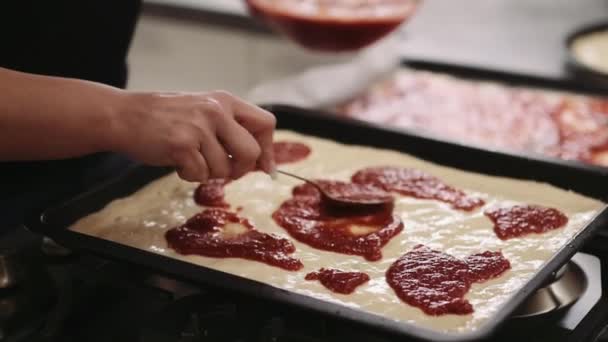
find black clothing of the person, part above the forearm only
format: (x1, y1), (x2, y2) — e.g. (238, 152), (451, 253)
(0, 0), (140, 87)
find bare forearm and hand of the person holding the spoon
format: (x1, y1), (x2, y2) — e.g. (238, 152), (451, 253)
(0, 68), (276, 182)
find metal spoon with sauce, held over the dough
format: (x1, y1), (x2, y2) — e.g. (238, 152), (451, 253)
(276, 170), (394, 208)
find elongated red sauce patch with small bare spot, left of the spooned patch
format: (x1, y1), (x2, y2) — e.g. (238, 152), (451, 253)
(165, 209), (303, 271)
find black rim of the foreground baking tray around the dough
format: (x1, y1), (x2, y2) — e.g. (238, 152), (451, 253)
(26, 106), (608, 341)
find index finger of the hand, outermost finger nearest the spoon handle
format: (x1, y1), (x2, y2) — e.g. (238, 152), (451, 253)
(216, 91), (276, 173)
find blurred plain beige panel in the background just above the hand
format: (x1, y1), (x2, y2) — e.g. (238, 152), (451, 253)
(129, 13), (352, 96)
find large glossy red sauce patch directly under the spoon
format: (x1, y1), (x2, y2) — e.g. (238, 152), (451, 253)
(272, 181), (403, 261)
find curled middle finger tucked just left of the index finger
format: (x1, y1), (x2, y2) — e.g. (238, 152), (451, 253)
(217, 120), (261, 179)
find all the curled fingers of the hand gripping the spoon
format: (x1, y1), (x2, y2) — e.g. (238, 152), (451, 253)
(170, 92), (276, 181)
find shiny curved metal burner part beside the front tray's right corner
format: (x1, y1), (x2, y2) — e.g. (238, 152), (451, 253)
(513, 261), (588, 318)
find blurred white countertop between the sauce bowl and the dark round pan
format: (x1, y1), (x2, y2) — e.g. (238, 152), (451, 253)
(403, 0), (608, 80)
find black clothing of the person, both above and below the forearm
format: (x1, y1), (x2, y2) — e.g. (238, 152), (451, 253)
(0, 0), (141, 229)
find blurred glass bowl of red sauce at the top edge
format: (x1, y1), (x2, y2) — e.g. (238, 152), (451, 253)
(245, 0), (420, 52)
